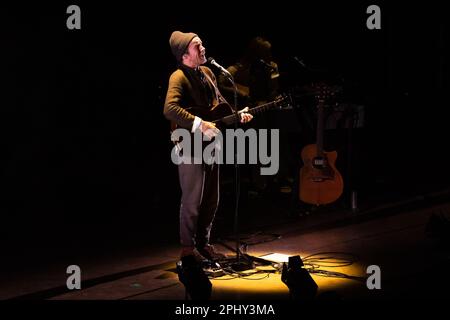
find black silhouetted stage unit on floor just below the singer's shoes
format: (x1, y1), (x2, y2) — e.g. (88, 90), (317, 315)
(177, 255), (212, 300)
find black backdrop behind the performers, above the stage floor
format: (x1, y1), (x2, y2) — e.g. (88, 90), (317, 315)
(0, 1), (450, 266)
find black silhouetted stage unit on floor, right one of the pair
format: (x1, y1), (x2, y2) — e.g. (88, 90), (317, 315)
(281, 256), (318, 300)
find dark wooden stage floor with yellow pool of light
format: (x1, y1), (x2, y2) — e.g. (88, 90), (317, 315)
(0, 190), (450, 301)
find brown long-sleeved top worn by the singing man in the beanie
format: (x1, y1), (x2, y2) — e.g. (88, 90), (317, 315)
(164, 66), (220, 130)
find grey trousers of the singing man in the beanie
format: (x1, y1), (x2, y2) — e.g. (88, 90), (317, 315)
(178, 163), (219, 247)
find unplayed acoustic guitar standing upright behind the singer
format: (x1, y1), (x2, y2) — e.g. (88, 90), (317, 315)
(299, 86), (344, 205)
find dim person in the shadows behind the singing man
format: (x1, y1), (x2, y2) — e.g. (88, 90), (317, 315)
(219, 37), (293, 194)
